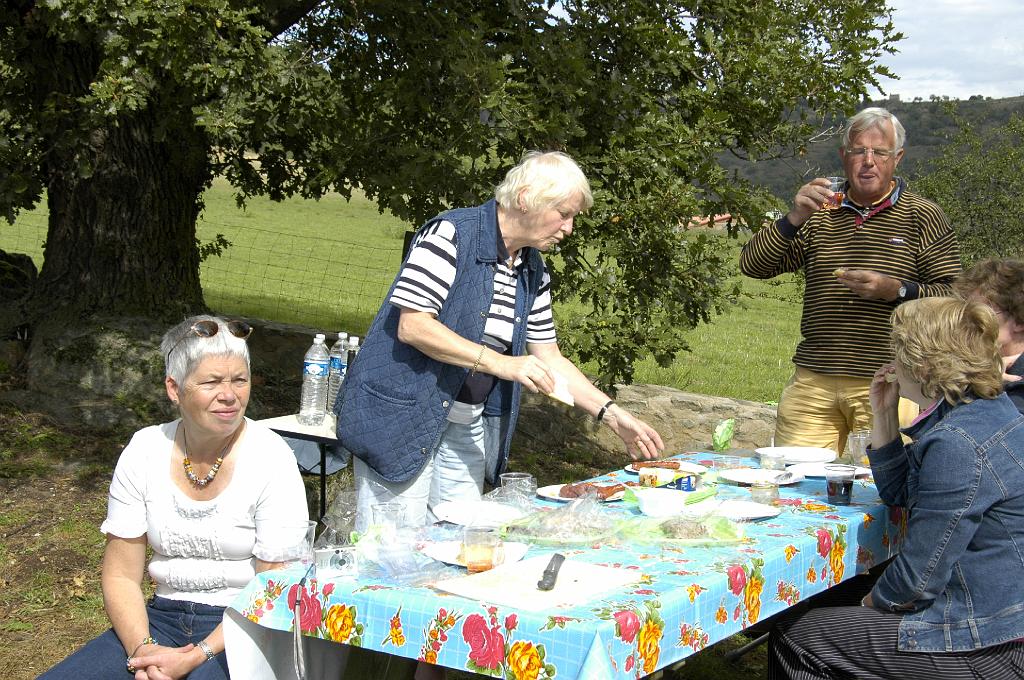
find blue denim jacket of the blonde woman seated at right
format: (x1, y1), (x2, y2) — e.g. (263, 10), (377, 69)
(868, 393), (1024, 652)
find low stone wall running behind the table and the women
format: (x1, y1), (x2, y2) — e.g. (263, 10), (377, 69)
(0, 318), (775, 456)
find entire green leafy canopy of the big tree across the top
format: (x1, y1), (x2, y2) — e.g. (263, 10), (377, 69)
(6, 0), (901, 384)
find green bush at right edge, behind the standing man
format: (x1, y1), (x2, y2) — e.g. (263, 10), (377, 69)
(914, 104), (1024, 265)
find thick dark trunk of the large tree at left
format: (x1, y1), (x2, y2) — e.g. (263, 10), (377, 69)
(30, 112), (209, 318)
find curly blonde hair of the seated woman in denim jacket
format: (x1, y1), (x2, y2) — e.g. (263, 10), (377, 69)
(891, 297), (1002, 403)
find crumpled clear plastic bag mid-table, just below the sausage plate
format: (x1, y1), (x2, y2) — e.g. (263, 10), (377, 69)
(504, 494), (614, 544)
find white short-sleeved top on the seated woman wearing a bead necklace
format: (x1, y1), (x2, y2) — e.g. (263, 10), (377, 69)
(100, 418), (308, 606)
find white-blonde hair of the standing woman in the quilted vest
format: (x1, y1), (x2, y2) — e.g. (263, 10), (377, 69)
(495, 152), (594, 212)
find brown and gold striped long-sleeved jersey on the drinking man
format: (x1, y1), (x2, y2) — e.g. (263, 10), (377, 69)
(739, 180), (961, 378)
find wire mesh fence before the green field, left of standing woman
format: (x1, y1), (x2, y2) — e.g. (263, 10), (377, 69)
(0, 209), (402, 333)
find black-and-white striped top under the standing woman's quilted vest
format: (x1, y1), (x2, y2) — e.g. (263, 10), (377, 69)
(390, 220), (557, 349)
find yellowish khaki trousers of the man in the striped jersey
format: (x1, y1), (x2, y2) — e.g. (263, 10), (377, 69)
(775, 366), (919, 455)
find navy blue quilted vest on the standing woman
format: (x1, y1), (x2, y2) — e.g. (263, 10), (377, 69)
(335, 201), (545, 482)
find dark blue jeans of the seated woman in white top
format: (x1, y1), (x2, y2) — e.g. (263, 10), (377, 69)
(38, 597), (230, 680)
